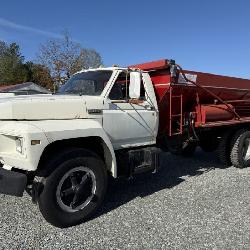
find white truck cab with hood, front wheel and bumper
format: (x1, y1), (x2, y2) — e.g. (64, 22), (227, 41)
(0, 67), (159, 227)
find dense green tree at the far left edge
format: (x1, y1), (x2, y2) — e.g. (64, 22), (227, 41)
(0, 41), (27, 84)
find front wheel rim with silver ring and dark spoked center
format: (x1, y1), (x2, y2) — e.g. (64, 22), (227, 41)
(56, 166), (96, 213)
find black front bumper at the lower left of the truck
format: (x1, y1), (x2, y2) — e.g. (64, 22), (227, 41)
(0, 167), (27, 197)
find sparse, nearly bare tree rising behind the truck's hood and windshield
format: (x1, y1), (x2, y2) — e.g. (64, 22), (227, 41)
(38, 32), (102, 83)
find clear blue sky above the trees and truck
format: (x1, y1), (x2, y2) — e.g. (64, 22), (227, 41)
(0, 0), (250, 79)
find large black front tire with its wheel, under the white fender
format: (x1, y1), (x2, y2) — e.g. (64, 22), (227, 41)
(38, 149), (107, 228)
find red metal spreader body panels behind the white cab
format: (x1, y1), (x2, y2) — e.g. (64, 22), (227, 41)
(129, 59), (250, 134)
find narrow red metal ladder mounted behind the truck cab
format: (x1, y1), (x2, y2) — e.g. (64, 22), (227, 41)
(169, 87), (183, 136)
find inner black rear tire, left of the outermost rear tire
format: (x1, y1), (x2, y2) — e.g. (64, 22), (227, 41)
(216, 130), (233, 166)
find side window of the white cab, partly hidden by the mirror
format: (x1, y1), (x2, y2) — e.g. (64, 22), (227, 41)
(109, 72), (146, 100)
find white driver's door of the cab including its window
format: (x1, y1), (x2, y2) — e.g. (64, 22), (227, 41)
(103, 71), (158, 149)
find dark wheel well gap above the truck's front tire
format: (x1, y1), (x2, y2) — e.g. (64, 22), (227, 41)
(38, 136), (105, 172)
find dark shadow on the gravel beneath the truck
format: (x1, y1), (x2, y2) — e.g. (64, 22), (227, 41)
(95, 150), (228, 217)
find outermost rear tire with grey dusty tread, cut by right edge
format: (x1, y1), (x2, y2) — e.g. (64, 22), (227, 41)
(230, 129), (250, 168)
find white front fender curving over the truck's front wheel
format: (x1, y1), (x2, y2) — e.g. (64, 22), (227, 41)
(0, 119), (117, 178)
